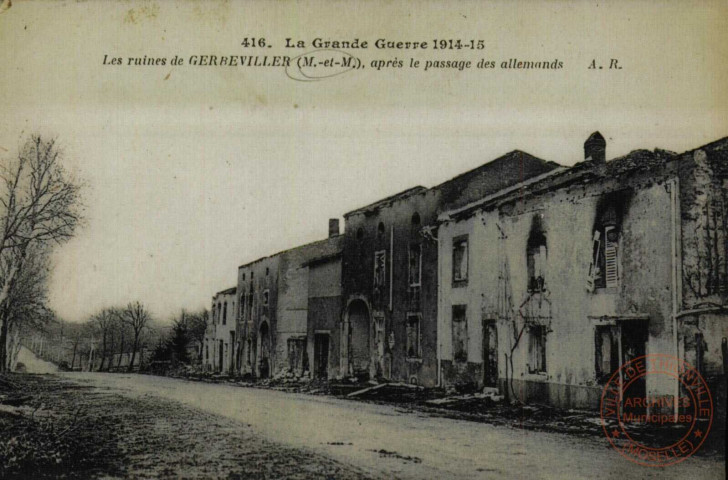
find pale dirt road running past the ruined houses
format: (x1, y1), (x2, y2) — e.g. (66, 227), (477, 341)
(62, 373), (723, 479)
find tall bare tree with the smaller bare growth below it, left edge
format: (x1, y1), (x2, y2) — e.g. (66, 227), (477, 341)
(0, 135), (83, 372)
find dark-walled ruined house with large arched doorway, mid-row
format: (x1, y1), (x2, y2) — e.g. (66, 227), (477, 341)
(339, 151), (558, 386)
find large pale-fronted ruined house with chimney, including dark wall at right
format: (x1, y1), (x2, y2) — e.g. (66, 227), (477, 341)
(436, 132), (728, 408)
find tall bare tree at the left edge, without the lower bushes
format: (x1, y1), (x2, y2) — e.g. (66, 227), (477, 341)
(0, 135), (81, 371)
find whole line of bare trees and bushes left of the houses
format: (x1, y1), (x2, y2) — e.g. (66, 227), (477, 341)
(0, 135), (208, 373)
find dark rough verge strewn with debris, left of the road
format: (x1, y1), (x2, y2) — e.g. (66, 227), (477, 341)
(0, 374), (371, 480)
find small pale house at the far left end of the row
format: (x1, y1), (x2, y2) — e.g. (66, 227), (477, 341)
(202, 287), (236, 373)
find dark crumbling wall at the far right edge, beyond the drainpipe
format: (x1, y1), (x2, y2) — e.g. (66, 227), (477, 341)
(678, 143), (728, 424)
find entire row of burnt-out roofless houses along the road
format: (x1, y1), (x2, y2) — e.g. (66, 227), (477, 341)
(204, 133), (728, 408)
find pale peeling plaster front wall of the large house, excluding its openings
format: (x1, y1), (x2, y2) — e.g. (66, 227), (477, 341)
(438, 169), (675, 407)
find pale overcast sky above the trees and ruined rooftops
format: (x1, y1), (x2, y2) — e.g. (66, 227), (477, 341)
(0, 2), (728, 320)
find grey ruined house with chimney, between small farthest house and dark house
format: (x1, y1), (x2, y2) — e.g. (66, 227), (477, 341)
(235, 220), (341, 378)
